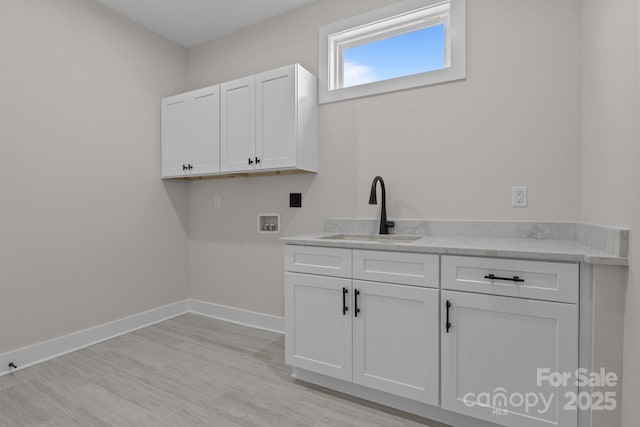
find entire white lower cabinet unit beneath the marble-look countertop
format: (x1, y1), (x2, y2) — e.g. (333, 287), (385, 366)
(285, 245), (579, 427)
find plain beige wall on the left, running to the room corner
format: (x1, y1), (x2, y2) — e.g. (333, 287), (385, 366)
(0, 0), (187, 353)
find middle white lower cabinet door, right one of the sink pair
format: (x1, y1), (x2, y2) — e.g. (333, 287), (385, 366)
(353, 280), (439, 405)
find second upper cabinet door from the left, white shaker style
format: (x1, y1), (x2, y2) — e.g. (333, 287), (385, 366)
(189, 85), (220, 175)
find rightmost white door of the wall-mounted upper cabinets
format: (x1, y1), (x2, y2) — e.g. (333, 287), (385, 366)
(256, 65), (298, 169)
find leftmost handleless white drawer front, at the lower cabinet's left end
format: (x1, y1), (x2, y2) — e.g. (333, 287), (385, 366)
(284, 245), (351, 278)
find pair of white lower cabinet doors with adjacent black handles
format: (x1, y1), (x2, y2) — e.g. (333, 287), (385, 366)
(285, 273), (439, 405)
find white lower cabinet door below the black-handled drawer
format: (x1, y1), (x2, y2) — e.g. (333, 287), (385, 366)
(441, 291), (578, 427)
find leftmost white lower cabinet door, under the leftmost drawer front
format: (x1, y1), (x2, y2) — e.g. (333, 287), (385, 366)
(285, 273), (352, 381)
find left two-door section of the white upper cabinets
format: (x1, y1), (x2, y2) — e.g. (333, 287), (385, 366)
(162, 86), (220, 178)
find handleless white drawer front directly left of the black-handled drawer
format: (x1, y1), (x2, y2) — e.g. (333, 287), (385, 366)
(353, 250), (439, 288)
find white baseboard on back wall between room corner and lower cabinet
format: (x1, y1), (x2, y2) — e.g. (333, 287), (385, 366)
(190, 300), (284, 334)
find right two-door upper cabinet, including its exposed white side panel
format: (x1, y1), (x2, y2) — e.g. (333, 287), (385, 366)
(221, 64), (318, 172)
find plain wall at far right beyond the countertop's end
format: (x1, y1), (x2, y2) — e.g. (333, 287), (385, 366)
(581, 0), (640, 427)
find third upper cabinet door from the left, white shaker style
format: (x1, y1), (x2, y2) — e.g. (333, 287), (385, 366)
(220, 76), (256, 172)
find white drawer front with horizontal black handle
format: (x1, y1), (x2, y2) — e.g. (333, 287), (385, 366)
(442, 256), (579, 303)
